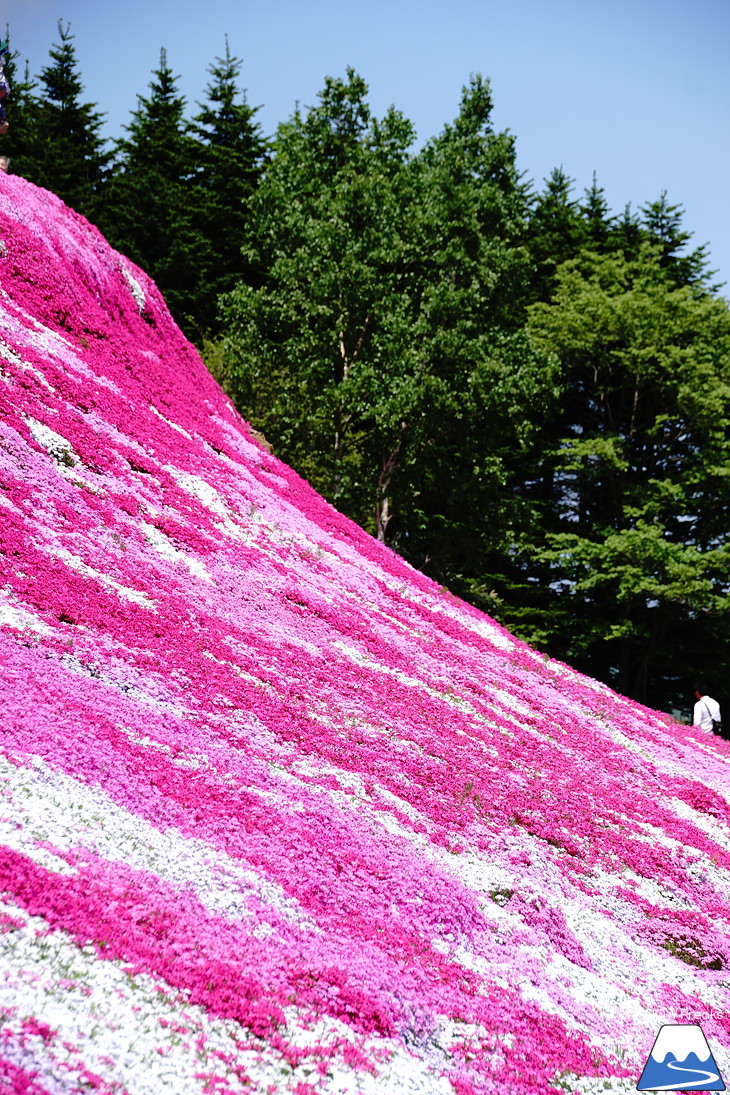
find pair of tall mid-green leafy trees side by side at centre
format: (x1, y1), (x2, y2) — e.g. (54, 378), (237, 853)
(222, 70), (551, 579)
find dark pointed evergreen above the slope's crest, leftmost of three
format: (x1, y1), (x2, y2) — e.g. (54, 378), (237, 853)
(24, 21), (109, 220)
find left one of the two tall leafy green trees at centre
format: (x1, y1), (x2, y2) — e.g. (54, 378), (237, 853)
(223, 72), (420, 527)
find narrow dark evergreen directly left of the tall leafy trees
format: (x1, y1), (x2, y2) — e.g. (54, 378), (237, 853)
(194, 37), (266, 331)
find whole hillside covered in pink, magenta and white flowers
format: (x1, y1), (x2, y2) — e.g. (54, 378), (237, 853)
(0, 175), (730, 1095)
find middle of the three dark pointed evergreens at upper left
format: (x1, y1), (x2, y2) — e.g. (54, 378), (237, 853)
(102, 49), (207, 337)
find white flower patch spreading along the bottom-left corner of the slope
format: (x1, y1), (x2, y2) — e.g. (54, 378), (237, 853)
(0, 902), (466, 1095)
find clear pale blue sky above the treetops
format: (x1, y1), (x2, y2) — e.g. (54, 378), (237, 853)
(5, 0), (730, 296)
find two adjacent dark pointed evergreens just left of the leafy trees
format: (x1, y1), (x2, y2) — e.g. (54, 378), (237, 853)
(102, 42), (265, 343)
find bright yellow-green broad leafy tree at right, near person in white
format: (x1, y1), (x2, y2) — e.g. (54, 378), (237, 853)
(520, 244), (730, 702)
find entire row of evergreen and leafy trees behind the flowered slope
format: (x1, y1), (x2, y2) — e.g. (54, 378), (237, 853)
(5, 25), (730, 710)
